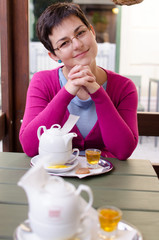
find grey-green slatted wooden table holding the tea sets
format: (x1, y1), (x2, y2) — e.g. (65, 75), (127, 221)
(0, 152), (159, 240)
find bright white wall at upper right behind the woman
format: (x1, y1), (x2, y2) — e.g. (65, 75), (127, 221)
(119, 0), (159, 110)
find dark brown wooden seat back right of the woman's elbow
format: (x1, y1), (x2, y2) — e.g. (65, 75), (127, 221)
(137, 112), (159, 177)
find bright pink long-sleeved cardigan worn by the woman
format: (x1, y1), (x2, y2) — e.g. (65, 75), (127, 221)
(19, 68), (138, 160)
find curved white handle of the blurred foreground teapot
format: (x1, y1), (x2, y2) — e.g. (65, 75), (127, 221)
(76, 184), (93, 218)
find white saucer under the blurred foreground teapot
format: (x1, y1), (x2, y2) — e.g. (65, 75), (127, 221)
(13, 218), (92, 240)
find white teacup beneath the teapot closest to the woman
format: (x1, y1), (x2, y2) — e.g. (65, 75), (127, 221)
(39, 148), (79, 166)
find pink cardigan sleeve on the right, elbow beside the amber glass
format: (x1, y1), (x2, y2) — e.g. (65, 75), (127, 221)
(91, 83), (138, 160)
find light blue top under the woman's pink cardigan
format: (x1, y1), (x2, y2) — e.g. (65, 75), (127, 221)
(59, 68), (107, 138)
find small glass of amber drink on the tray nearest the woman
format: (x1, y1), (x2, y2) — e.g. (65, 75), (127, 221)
(85, 148), (101, 168)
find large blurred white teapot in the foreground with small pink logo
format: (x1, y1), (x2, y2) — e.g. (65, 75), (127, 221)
(18, 166), (93, 240)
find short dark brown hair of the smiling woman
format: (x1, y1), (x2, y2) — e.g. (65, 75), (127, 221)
(36, 2), (90, 54)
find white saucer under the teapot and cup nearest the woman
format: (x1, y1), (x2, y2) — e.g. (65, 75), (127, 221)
(30, 154), (78, 173)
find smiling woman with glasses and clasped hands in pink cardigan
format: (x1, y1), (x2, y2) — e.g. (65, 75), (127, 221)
(20, 3), (138, 160)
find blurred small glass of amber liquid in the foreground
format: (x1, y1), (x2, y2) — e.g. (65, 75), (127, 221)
(97, 206), (122, 240)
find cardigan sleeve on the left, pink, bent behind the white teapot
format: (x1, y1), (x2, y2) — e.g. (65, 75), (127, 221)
(19, 72), (74, 157)
